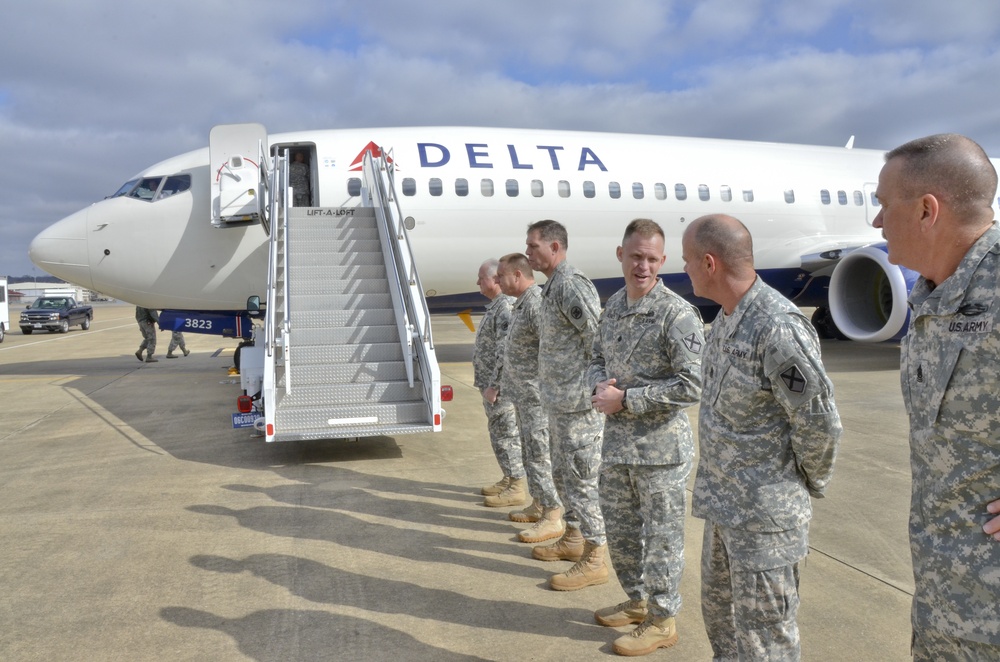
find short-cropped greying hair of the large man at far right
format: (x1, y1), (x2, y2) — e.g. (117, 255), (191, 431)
(885, 133), (997, 221)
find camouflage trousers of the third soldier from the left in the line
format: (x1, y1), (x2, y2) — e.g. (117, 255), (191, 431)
(549, 409), (607, 545)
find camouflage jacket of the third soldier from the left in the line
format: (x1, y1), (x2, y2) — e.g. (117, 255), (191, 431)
(538, 260), (601, 414)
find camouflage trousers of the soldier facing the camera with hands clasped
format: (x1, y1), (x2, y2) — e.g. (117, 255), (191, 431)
(601, 462), (692, 618)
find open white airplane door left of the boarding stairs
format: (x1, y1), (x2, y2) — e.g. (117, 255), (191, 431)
(208, 123), (267, 227)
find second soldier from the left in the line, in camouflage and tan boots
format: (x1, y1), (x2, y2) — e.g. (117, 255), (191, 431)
(497, 253), (566, 543)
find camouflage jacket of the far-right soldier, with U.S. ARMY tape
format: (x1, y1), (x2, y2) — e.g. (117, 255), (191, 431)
(900, 224), (1000, 644)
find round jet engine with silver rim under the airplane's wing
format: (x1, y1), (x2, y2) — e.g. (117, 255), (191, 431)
(829, 244), (919, 342)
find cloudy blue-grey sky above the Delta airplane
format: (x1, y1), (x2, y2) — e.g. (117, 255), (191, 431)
(0, 0), (1000, 276)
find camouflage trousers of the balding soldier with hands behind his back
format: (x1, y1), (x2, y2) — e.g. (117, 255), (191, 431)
(701, 520), (809, 662)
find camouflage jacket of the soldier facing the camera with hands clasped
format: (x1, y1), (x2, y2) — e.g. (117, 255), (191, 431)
(587, 280), (705, 464)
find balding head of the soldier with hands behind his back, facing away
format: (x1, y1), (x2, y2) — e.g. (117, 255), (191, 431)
(682, 214), (757, 314)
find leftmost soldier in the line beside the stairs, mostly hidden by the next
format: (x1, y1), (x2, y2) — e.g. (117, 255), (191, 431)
(472, 259), (527, 508)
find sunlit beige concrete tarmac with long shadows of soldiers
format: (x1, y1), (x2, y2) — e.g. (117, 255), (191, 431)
(0, 304), (913, 662)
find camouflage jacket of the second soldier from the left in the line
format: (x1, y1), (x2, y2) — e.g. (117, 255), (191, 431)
(500, 285), (542, 406)
